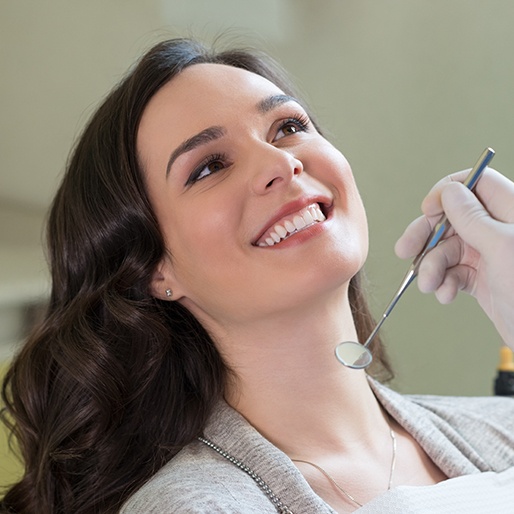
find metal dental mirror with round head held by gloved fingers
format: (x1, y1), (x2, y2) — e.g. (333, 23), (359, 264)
(335, 148), (494, 369)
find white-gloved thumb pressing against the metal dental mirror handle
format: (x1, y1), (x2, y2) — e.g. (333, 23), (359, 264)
(441, 182), (497, 250)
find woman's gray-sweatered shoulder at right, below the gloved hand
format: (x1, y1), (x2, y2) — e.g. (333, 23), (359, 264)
(372, 383), (514, 474)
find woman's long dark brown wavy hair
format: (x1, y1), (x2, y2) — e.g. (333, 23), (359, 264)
(2, 39), (390, 514)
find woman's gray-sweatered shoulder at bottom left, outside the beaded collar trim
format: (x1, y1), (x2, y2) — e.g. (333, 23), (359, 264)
(120, 436), (276, 514)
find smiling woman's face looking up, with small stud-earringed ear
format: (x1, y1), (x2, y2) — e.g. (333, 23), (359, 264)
(137, 64), (367, 327)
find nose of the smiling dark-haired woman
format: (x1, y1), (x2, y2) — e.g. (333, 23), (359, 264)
(251, 143), (303, 195)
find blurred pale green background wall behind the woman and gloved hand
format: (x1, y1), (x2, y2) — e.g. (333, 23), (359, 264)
(0, 0), (514, 484)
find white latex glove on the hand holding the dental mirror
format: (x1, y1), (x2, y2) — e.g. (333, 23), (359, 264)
(395, 168), (514, 349)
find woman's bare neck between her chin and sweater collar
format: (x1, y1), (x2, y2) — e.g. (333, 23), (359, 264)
(217, 290), (386, 458)
